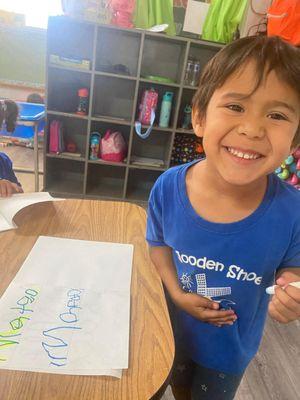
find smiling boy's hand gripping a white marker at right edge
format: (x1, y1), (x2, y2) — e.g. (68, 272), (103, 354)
(269, 271), (300, 324)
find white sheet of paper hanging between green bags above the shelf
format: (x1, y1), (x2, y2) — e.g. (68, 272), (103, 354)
(183, 0), (210, 35)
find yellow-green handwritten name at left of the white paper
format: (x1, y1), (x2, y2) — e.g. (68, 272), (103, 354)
(0, 288), (39, 361)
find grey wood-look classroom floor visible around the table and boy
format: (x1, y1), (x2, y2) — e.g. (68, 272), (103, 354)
(0, 142), (300, 400)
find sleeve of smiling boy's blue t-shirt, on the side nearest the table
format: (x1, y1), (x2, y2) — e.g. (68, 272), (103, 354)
(146, 178), (166, 246)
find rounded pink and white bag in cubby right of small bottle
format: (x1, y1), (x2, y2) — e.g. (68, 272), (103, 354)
(100, 129), (127, 162)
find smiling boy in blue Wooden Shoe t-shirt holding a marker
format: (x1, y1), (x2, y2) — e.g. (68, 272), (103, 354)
(147, 36), (300, 400)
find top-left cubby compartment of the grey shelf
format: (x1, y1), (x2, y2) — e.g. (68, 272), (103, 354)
(48, 17), (95, 69)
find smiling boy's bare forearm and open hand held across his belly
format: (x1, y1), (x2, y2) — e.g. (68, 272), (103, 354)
(149, 246), (237, 326)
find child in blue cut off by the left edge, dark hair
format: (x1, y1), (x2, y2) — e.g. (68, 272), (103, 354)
(0, 100), (23, 197)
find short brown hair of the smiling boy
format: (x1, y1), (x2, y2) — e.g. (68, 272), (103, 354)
(193, 36), (300, 147)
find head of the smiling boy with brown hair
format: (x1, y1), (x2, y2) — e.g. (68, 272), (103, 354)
(193, 36), (300, 185)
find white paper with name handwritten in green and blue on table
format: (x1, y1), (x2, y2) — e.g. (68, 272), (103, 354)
(0, 236), (133, 377)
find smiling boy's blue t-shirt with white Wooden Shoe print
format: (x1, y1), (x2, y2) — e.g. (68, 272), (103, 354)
(146, 162), (300, 374)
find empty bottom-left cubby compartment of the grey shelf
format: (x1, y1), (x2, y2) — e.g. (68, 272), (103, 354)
(45, 156), (85, 195)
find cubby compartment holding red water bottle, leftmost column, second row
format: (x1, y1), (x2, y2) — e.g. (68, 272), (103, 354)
(47, 67), (91, 113)
